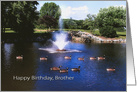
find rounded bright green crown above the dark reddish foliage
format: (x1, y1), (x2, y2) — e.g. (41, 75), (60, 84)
(40, 2), (61, 20)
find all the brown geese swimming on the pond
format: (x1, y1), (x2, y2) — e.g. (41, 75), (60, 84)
(16, 55), (115, 73)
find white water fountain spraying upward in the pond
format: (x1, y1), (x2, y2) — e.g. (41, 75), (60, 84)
(39, 17), (81, 53)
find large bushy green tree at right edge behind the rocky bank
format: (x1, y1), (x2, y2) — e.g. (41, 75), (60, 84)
(97, 6), (126, 37)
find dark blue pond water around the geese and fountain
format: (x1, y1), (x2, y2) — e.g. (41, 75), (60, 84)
(1, 42), (126, 91)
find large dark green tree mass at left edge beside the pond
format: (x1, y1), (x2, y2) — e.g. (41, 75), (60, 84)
(2, 1), (38, 39)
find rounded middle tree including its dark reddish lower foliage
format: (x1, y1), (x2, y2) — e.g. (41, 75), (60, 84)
(36, 2), (61, 28)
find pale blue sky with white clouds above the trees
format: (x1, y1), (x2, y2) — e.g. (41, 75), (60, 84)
(37, 1), (126, 20)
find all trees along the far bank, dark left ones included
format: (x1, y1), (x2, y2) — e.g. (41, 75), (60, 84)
(1, 1), (126, 38)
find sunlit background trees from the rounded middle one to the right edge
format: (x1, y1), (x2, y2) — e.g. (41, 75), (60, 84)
(36, 3), (126, 37)
